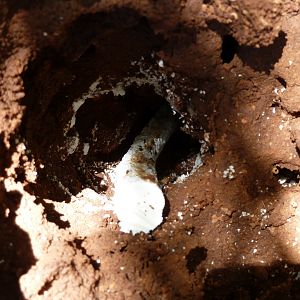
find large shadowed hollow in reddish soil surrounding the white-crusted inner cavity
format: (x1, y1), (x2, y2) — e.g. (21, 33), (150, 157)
(18, 8), (200, 202)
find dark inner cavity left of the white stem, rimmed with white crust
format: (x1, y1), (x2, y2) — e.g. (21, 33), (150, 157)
(75, 85), (165, 162)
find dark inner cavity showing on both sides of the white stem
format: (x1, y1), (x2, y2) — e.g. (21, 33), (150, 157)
(75, 85), (200, 187)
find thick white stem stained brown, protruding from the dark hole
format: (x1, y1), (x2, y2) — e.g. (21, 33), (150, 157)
(113, 106), (176, 234)
